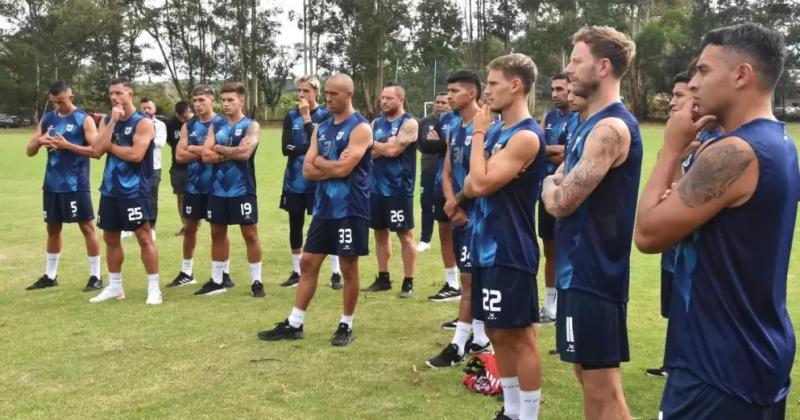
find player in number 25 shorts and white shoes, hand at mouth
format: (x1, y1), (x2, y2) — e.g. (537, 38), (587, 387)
(89, 79), (162, 305)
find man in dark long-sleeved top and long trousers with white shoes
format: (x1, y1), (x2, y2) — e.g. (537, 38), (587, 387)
(417, 92), (450, 252)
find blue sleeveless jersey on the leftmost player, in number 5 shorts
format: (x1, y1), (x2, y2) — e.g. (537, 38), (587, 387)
(42, 108), (89, 193)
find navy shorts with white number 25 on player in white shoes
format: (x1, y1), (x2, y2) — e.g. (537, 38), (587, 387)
(97, 195), (153, 232)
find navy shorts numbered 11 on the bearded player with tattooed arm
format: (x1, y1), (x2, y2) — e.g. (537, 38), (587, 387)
(556, 289), (630, 369)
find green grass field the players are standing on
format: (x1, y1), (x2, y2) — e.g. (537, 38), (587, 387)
(0, 125), (800, 419)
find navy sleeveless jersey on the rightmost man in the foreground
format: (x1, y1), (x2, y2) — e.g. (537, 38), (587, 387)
(665, 119), (800, 405)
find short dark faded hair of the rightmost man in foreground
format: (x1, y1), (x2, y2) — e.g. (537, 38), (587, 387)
(701, 22), (786, 90)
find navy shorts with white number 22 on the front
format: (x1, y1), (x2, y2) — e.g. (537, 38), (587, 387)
(471, 266), (539, 329)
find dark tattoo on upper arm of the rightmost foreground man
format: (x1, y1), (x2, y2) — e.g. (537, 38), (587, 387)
(678, 144), (754, 207)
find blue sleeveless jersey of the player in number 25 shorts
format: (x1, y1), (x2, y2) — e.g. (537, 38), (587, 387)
(100, 111), (153, 198)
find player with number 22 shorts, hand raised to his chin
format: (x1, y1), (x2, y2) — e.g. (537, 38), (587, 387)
(456, 54), (546, 419)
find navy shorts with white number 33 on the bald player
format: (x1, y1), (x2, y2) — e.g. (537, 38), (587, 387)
(303, 216), (369, 257)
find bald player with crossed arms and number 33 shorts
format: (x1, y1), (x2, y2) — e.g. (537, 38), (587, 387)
(258, 74), (372, 346)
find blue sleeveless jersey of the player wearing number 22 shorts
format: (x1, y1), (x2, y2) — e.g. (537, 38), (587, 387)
(470, 118), (546, 274)
